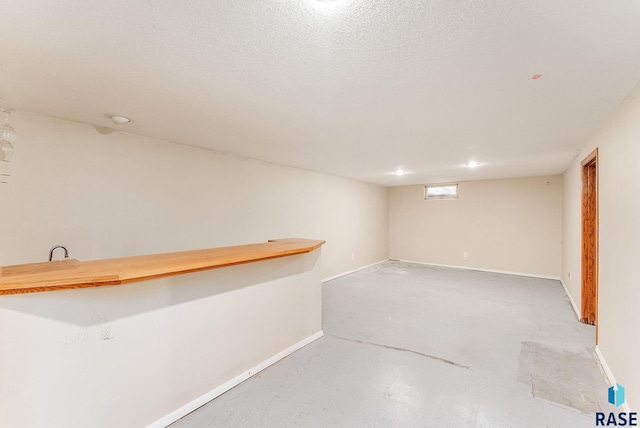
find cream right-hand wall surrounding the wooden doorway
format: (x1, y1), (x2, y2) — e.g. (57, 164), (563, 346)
(562, 86), (640, 409)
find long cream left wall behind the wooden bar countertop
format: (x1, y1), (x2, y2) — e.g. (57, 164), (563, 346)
(0, 112), (388, 277)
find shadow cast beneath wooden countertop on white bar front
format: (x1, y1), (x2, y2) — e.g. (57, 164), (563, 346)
(0, 249), (321, 327)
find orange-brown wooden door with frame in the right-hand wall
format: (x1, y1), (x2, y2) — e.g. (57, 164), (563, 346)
(581, 149), (598, 343)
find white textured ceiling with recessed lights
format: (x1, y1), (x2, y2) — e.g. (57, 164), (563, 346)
(0, 0), (640, 186)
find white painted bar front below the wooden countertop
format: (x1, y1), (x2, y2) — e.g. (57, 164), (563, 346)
(0, 250), (322, 428)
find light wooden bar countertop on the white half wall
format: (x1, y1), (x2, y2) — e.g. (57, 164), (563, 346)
(0, 238), (325, 294)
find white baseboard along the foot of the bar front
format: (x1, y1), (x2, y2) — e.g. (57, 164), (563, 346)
(147, 330), (324, 428)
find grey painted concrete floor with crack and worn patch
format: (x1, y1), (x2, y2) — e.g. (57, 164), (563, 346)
(171, 261), (614, 428)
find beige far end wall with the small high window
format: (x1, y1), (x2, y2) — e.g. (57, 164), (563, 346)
(389, 176), (562, 277)
